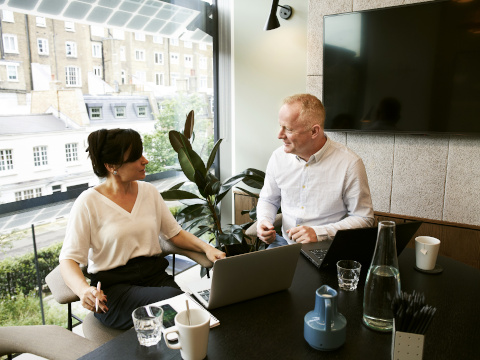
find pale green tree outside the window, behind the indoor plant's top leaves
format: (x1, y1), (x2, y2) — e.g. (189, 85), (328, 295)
(143, 92), (213, 174)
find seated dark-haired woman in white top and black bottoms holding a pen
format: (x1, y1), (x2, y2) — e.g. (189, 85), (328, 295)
(60, 129), (225, 329)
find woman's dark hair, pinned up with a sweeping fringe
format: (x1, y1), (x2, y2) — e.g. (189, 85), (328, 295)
(86, 129), (143, 177)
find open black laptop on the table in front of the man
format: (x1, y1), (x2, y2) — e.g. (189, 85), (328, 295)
(301, 221), (422, 268)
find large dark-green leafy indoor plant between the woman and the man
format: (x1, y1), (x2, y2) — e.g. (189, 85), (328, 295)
(161, 110), (265, 256)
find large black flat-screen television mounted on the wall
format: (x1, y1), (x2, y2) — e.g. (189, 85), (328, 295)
(323, 0), (480, 136)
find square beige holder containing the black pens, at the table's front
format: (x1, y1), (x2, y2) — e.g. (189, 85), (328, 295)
(392, 320), (425, 360)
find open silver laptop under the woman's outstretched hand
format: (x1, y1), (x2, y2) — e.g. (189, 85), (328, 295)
(187, 244), (302, 309)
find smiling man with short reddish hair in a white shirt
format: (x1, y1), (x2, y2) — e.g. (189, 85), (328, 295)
(257, 94), (374, 248)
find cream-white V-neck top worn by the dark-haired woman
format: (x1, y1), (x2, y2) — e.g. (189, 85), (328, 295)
(60, 181), (182, 274)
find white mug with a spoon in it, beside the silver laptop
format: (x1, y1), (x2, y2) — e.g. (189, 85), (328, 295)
(163, 309), (210, 360)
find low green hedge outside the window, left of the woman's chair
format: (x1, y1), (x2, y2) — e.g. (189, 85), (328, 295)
(0, 243), (62, 299)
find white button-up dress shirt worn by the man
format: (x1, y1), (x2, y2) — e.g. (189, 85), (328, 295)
(257, 137), (374, 243)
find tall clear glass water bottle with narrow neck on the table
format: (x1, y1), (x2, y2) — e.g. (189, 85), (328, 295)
(363, 221), (400, 332)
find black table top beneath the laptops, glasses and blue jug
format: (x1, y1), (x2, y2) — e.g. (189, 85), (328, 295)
(81, 249), (480, 360)
